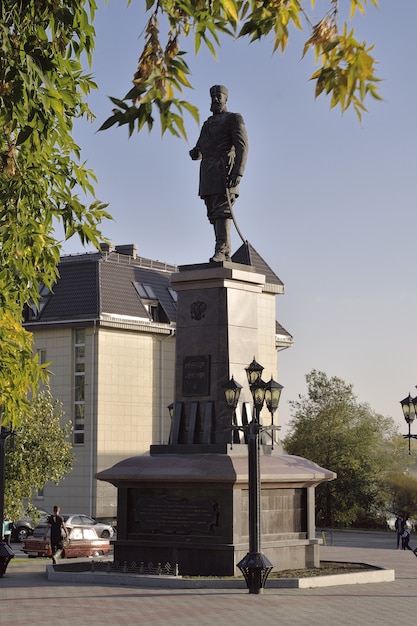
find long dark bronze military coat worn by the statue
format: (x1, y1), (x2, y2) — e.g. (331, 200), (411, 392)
(195, 112), (248, 198)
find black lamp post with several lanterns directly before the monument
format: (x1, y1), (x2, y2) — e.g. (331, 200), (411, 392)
(224, 359), (283, 593)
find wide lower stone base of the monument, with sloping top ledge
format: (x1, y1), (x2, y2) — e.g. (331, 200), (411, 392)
(97, 444), (334, 576)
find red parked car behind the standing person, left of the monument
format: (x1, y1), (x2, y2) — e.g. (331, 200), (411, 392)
(22, 524), (111, 559)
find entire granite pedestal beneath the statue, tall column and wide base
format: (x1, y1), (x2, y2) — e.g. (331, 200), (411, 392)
(97, 255), (335, 576)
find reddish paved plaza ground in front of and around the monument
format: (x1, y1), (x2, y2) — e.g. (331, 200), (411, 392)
(0, 546), (417, 626)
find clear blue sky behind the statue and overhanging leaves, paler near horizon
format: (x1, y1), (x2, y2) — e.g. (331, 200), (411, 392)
(64, 0), (417, 433)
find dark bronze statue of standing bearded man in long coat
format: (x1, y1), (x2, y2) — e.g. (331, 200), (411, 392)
(190, 85), (248, 262)
